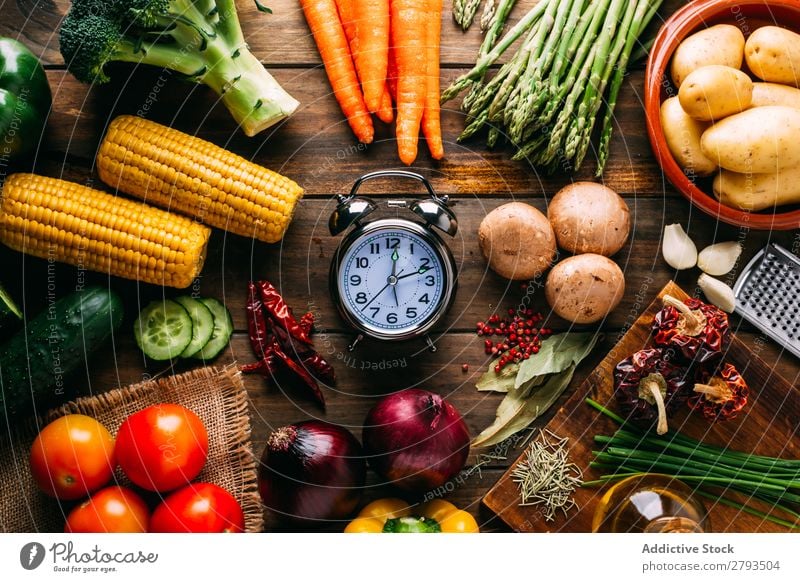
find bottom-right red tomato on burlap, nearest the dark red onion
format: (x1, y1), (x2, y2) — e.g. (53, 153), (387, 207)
(150, 483), (244, 533)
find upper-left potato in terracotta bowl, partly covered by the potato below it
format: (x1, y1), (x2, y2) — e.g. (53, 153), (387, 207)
(670, 24), (744, 88)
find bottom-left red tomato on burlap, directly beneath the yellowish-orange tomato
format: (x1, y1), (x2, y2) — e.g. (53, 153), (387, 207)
(64, 485), (150, 533)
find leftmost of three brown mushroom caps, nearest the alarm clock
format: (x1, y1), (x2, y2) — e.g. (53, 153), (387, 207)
(478, 202), (556, 281)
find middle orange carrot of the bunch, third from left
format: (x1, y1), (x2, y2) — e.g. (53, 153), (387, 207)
(353, 0), (389, 111)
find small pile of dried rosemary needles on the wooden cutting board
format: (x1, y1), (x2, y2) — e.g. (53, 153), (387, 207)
(511, 430), (583, 521)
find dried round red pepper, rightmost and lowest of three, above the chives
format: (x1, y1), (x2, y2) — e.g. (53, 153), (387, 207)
(688, 363), (750, 420)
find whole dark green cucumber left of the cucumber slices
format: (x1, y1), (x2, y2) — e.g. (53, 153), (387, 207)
(0, 287), (122, 425)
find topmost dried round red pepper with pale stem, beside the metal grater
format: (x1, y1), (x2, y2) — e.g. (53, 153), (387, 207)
(653, 295), (730, 364)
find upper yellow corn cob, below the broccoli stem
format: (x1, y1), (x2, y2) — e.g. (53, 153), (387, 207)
(97, 115), (303, 243)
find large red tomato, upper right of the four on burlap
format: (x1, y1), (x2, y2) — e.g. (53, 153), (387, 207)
(116, 404), (208, 491)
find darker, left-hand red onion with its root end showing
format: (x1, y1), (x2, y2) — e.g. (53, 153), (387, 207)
(258, 420), (366, 521)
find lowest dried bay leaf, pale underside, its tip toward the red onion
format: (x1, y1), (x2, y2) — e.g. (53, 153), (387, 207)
(472, 364), (578, 448)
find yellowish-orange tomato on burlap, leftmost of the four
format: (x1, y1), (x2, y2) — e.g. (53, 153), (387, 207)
(30, 414), (114, 499)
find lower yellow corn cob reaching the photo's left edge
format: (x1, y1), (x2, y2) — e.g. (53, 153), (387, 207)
(0, 174), (211, 288)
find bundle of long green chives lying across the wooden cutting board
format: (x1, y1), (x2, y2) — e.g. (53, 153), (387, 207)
(584, 398), (800, 530)
